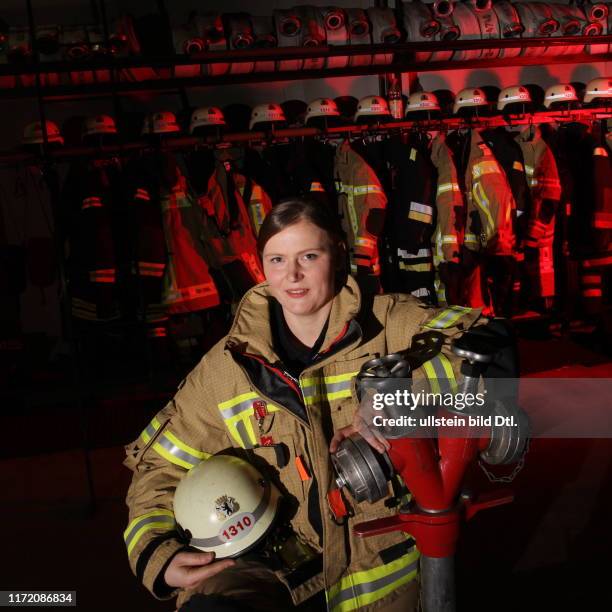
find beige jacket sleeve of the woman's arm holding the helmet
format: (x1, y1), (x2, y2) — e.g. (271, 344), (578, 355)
(124, 356), (232, 599)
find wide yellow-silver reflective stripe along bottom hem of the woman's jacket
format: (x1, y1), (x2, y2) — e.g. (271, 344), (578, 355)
(326, 547), (420, 612)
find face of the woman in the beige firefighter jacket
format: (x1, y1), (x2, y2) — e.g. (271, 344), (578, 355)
(263, 219), (335, 317)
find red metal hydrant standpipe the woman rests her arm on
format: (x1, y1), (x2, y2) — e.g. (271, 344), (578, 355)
(332, 344), (528, 612)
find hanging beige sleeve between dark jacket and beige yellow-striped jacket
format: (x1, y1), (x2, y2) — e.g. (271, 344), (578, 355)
(431, 136), (464, 263)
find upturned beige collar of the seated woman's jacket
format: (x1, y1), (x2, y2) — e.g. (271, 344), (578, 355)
(225, 276), (361, 363)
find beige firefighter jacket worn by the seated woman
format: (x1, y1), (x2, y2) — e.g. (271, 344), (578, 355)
(125, 278), (479, 612)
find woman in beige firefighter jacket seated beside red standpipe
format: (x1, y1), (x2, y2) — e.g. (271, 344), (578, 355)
(125, 200), (479, 612)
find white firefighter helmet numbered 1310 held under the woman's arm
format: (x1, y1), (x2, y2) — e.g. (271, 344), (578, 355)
(174, 455), (280, 559)
